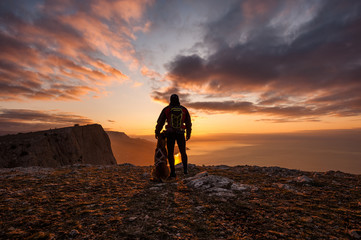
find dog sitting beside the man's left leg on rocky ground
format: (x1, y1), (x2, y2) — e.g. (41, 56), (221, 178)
(152, 132), (169, 182)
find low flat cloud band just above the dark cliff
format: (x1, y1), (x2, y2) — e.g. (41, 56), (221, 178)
(0, 108), (94, 134)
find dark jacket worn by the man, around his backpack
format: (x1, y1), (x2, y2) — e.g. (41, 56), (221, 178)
(155, 105), (192, 136)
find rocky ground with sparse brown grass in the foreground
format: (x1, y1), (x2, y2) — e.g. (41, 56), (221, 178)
(0, 164), (361, 239)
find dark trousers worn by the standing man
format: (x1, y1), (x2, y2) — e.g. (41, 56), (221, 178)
(167, 131), (188, 176)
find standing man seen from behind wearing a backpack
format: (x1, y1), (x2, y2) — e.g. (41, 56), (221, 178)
(155, 94), (192, 178)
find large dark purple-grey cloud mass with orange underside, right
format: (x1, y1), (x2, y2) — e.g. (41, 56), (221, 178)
(152, 0), (361, 121)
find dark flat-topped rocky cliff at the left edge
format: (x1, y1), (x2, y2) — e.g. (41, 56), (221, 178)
(0, 124), (116, 168)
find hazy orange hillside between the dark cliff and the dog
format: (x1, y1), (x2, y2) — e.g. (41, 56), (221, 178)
(107, 131), (156, 166)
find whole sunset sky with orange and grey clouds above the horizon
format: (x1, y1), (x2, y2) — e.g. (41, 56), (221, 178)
(0, 0), (361, 135)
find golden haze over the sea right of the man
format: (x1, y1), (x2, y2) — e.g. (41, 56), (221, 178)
(179, 129), (361, 174)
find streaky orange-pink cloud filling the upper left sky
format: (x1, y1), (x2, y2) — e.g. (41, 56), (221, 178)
(0, 0), (151, 101)
